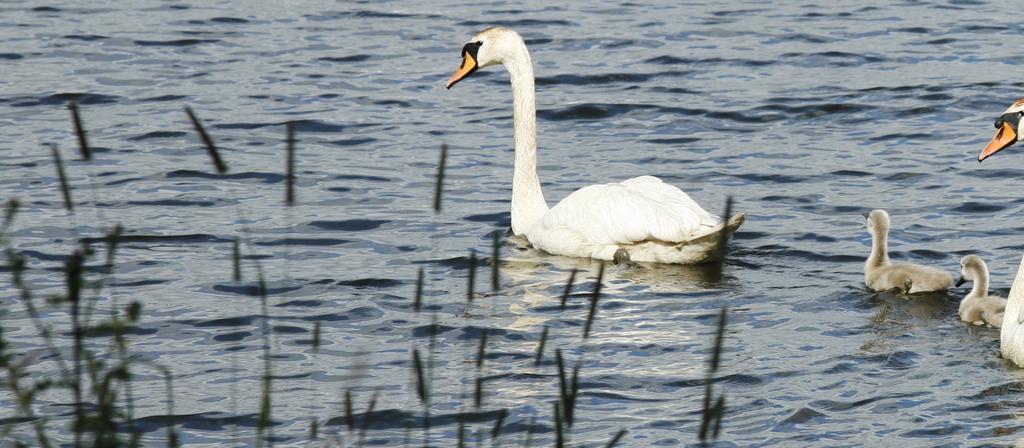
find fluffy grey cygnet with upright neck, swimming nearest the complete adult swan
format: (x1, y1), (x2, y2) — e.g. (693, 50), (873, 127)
(864, 210), (953, 294)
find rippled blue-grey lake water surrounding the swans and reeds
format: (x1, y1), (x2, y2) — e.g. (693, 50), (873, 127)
(6, 0), (1024, 447)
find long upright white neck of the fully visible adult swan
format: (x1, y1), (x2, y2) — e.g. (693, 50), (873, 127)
(505, 45), (548, 234)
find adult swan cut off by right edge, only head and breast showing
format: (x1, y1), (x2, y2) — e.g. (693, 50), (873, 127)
(978, 98), (1024, 367)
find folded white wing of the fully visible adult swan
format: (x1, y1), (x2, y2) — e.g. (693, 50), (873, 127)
(541, 176), (720, 244)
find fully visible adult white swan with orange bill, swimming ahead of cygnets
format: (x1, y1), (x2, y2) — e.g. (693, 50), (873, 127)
(447, 27), (743, 264)
